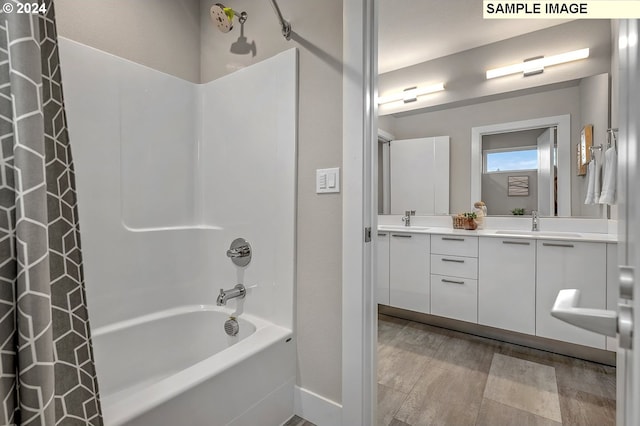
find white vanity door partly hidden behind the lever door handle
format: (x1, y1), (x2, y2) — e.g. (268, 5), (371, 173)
(536, 240), (607, 349)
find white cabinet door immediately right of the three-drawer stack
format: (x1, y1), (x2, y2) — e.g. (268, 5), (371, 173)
(478, 237), (536, 334)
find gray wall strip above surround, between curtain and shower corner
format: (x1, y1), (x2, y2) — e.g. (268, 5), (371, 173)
(55, 0), (200, 83)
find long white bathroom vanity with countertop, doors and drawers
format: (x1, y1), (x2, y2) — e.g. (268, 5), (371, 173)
(377, 226), (617, 356)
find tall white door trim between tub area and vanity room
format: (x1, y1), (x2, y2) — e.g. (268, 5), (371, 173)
(342, 0), (378, 426)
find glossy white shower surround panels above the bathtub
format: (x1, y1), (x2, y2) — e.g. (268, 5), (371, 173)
(60, 39), (297, 328)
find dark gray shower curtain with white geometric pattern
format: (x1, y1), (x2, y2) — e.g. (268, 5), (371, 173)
(0, 0), (102, 426)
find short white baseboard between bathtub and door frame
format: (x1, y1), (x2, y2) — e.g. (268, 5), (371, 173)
(293, 386), (342, 426)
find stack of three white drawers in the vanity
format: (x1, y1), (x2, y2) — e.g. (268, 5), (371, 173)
(431, 235), (478, 323)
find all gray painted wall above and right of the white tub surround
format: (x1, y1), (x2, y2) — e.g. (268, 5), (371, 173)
(55, 0), (343, 403)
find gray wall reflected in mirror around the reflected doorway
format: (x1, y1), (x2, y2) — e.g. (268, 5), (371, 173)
(382, 86), (580, 213)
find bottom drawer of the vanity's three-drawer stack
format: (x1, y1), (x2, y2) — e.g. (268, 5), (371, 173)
(431, 274), (478, 323)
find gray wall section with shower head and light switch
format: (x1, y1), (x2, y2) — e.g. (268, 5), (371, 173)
(200, 0), (343, 402)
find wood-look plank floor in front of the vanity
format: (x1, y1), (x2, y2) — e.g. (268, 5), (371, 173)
(378, 315), (616, 426)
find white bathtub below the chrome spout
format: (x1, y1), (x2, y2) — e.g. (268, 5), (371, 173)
(92, 305), (295, 426)
